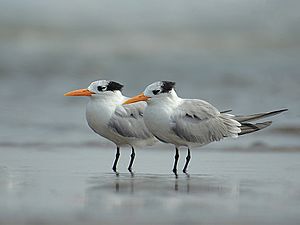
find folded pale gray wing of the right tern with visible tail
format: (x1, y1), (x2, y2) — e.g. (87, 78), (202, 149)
(171, 100), (241, 144)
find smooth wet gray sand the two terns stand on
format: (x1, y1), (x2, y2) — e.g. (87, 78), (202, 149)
(0, 147), (300, 224)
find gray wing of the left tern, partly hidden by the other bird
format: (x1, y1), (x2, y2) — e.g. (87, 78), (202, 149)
(108, 102), (153, 139)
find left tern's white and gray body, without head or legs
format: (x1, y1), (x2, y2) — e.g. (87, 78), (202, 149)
(86, 91), (156, 146)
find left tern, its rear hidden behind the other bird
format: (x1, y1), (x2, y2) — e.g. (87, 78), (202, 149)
(64, 80), (157, 175)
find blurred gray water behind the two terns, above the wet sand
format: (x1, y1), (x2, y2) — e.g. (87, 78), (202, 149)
(0, 0), (300, 146)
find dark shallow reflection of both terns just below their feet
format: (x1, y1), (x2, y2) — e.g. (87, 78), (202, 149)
(87, 174), (238, 195)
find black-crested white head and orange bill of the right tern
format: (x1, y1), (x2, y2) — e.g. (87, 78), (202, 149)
(124, 81), (177, 104)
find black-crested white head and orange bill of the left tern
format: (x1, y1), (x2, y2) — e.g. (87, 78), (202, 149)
(65, 80), (123, 97)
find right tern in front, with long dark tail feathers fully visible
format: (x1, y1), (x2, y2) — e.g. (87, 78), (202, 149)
(124, 81), (287, 177)
